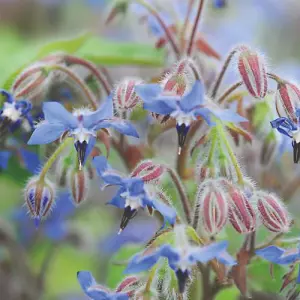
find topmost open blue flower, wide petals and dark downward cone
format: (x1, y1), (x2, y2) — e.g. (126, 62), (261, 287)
(135, 80), (247, 153)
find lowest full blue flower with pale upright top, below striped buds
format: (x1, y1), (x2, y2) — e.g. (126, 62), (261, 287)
(125, 225), (236, 293)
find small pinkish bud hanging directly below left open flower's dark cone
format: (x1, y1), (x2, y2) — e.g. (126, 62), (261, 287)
(68, 168), (90, 205)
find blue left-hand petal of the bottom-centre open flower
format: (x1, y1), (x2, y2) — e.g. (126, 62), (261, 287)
(124, 252), (160, 274)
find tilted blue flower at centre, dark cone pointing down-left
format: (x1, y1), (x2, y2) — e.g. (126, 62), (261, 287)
(93, 156), (176, 232)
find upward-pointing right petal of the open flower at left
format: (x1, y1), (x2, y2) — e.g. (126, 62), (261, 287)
(83, 95), (114, 130)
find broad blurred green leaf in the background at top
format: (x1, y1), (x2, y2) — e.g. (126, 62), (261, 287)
(75, 37), (165, 66)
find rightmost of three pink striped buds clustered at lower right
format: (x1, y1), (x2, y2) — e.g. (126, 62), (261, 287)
(256, 191), (291, 233)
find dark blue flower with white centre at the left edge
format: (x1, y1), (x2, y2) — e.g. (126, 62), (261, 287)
(0, 90), (33, 133)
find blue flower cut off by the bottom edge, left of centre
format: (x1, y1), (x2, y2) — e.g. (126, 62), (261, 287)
(77, 271), (129, 300)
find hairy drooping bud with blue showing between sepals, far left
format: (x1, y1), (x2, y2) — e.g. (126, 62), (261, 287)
(25, 177), (55, 226)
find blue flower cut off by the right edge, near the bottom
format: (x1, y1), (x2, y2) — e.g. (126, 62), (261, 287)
(255, 246), (300, 283)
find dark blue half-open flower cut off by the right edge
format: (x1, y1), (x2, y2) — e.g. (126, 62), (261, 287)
(270, 109), (300, 163)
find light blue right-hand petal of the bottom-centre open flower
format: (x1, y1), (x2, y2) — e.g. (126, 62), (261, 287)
(190, 241), (228, 263)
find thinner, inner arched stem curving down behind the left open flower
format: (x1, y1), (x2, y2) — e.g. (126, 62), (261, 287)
(43, 64), (98, 110)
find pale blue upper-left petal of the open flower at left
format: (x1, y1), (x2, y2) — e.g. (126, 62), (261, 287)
(43, 102), (77, 129)
